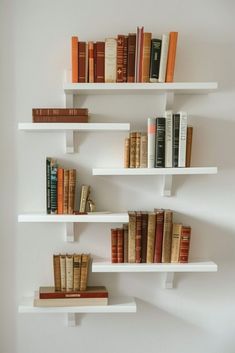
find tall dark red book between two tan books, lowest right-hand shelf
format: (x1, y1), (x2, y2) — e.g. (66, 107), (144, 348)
(153, 209), (164, 263)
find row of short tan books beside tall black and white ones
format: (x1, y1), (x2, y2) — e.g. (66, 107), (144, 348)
(124, 111), (193, 168)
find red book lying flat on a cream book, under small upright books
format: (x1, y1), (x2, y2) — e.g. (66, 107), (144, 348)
(39, 286), (108, 299)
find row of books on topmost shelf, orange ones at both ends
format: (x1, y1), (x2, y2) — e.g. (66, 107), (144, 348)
(71, 27), (178, 83)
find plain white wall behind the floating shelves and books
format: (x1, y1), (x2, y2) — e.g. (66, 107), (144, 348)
(0, 0), (235, 353)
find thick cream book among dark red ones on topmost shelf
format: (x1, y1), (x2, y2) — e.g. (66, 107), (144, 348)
(104, 38), (117, 83)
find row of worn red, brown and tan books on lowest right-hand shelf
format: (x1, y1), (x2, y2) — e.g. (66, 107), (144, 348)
(111, 209), (191, 263)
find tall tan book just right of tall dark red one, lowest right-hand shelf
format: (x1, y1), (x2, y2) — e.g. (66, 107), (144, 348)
(162, 210), (173, 263)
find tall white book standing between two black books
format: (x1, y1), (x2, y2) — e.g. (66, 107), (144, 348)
(165, 110), (173, 168)
